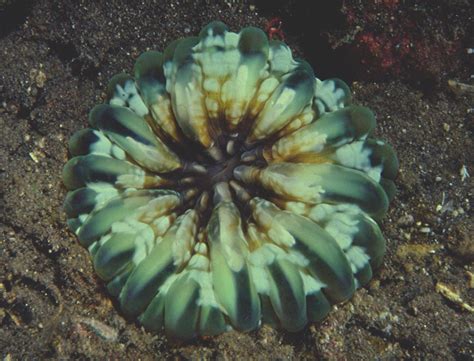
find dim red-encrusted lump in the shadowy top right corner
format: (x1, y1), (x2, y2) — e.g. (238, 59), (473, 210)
(331, 0), (462, 81)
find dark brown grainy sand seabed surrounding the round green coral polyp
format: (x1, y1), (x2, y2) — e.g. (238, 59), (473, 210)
(0, 0), (474, 360)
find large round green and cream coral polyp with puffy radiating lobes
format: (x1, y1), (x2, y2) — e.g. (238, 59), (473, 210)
(63, 22), (398, 338)
